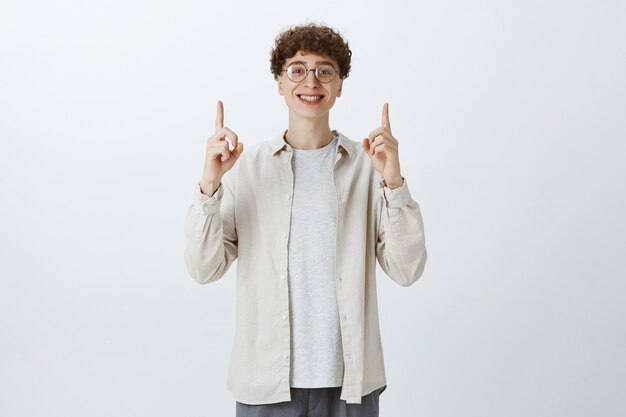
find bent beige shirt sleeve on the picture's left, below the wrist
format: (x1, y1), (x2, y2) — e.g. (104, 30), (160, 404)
(184, 173), (238, 284)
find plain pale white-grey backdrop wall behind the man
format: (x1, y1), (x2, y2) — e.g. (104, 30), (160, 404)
(0, 0), (626, 417)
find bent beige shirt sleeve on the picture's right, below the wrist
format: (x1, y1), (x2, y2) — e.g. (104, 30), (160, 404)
(376, 177), (428, 287)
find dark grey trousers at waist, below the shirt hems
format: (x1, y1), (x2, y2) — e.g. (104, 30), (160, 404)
(236, 387), (381, 417)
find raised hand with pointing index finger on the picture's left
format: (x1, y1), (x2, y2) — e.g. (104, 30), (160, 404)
(200, 100), (243, 195)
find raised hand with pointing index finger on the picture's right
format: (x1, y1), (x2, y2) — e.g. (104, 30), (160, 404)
(362, 103), (402, 188)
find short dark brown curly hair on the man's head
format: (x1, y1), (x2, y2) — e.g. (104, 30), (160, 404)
(270, 23), (352, 80)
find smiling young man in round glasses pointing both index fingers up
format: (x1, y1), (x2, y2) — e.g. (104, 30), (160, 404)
(185, 24), (427, 417)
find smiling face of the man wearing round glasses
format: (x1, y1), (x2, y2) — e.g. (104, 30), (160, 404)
(278, 51), (343, 118)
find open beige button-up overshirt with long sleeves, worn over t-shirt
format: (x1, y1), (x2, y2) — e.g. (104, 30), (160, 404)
(184, 132), (427, 404)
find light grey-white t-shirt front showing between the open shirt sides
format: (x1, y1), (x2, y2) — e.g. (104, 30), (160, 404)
(288, 137), (344, 388)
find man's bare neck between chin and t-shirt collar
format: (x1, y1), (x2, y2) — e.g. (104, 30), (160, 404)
(285, 112), (334, 149)
